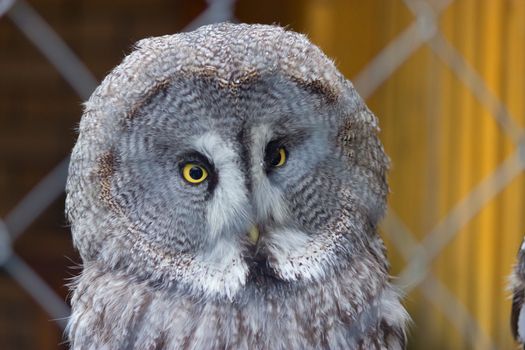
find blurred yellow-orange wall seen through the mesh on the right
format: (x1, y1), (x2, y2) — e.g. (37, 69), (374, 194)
(298, 0), (525, 349)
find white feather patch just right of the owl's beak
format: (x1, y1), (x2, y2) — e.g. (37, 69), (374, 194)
(264, 229), (334, 281)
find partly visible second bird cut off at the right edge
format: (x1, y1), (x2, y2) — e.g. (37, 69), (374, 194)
(510, 239), (525, 349)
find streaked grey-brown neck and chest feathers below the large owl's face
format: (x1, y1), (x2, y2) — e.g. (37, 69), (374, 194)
(69, 253), (406, 349)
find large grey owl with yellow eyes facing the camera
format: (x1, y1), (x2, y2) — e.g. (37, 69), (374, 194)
(66, 23), (408, 350)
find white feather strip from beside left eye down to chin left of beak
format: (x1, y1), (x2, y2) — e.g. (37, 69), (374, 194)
(189, 132), (250, 299)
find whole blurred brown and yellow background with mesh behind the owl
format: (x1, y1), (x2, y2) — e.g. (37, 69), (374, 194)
(0, 0), (525, 349)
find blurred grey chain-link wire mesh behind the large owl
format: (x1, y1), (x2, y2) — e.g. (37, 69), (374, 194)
(0, 0), (525, 349)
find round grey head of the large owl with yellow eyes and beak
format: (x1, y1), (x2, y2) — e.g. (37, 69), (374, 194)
(66, 23), (388, 298)
